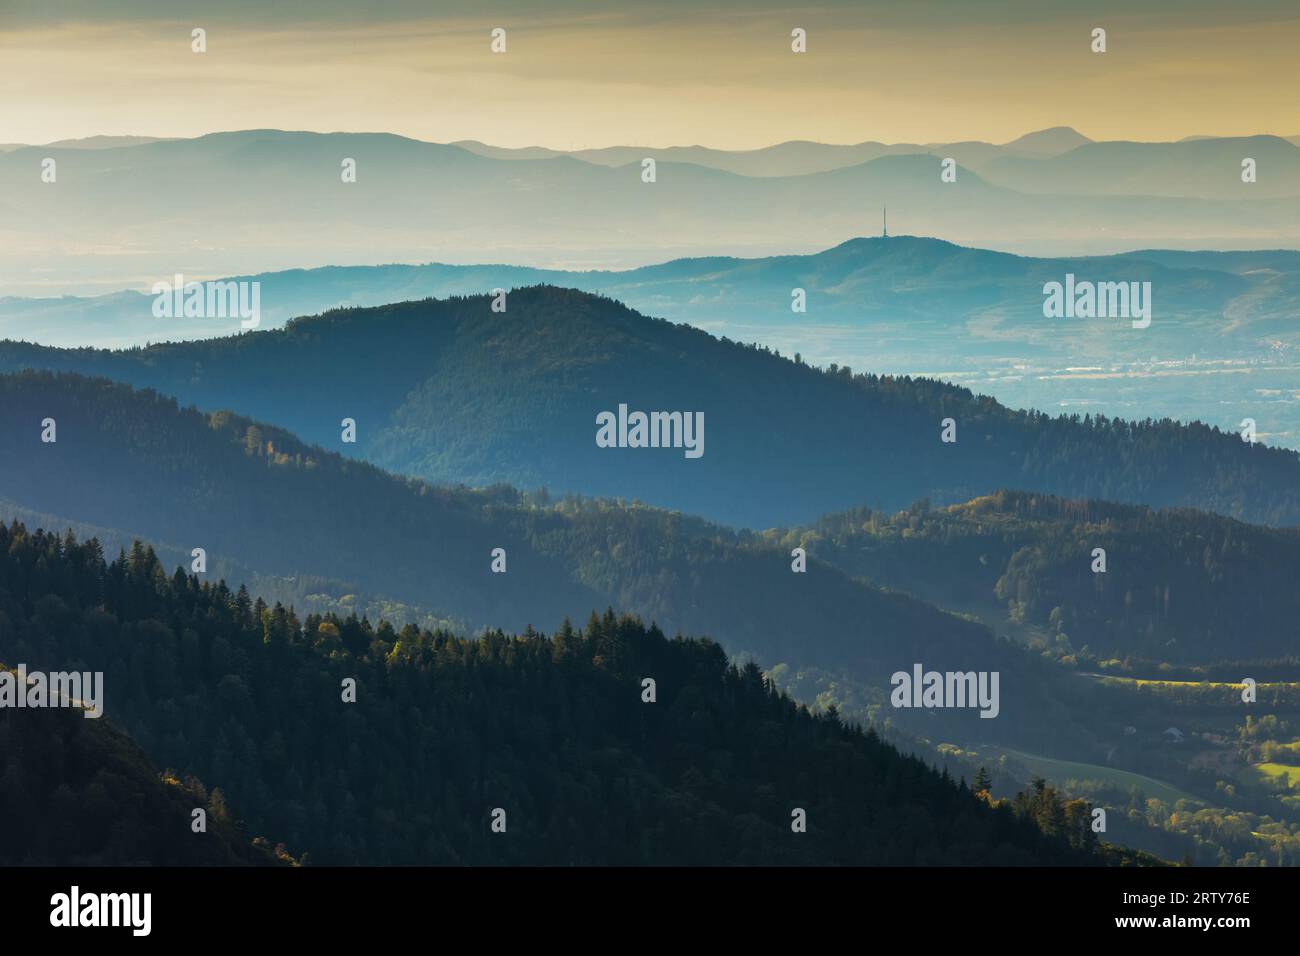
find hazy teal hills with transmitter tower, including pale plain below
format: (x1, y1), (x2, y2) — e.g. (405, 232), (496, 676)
(0, 235), (1300, 447)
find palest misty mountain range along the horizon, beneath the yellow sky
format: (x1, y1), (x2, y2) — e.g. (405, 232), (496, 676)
(0, 130), (1300, 295)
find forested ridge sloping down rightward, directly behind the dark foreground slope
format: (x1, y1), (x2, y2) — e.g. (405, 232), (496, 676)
(0, 372), (1084, 745)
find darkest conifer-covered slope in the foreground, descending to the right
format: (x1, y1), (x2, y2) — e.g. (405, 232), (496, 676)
(0, 524), (1118, 865)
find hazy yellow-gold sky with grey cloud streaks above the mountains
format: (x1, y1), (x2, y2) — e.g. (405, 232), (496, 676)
(0, 0), (1300, 148)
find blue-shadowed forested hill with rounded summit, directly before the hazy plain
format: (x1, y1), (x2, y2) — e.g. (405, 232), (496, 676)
(0, 286), (1300, 528)
